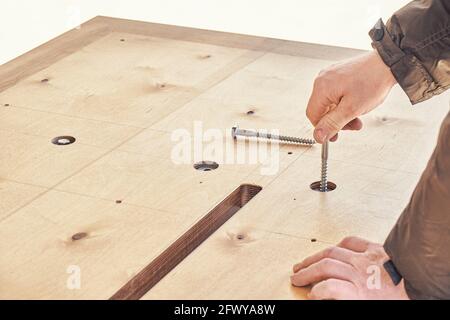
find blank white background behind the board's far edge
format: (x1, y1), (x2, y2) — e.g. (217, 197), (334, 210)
(0, 0), (408, 64)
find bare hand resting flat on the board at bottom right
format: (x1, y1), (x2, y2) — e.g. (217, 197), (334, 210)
(291, 237), (408, 300)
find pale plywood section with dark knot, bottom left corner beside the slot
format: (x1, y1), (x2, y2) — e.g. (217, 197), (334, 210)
(0, 191), (197, 299)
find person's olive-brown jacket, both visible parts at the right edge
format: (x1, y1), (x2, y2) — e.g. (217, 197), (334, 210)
(369, 0), (450, 299)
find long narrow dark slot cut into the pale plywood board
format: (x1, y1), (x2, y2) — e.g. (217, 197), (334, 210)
(110, 184), (262, 300)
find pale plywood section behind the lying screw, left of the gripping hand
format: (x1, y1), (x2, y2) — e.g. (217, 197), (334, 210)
(152, 53), (331, 137)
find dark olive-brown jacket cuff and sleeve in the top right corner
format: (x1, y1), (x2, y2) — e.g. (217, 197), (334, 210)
(369, 0), (450, 104)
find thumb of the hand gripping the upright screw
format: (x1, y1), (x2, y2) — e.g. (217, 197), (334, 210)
(314, 98), (355, 143)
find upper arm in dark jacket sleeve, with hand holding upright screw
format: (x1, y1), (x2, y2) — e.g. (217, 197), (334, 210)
(306, 0), (450, 143)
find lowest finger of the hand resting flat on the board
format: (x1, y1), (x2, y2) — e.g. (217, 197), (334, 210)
(308, 279), (358, 300)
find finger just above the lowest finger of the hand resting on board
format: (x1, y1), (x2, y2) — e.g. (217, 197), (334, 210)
(291, 258), (355, 287)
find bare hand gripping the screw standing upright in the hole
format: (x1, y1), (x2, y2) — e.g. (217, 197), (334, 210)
(306, 51), (396, 143)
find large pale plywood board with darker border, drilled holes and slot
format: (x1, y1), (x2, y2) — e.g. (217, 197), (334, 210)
(0, 17), (449, 299)
